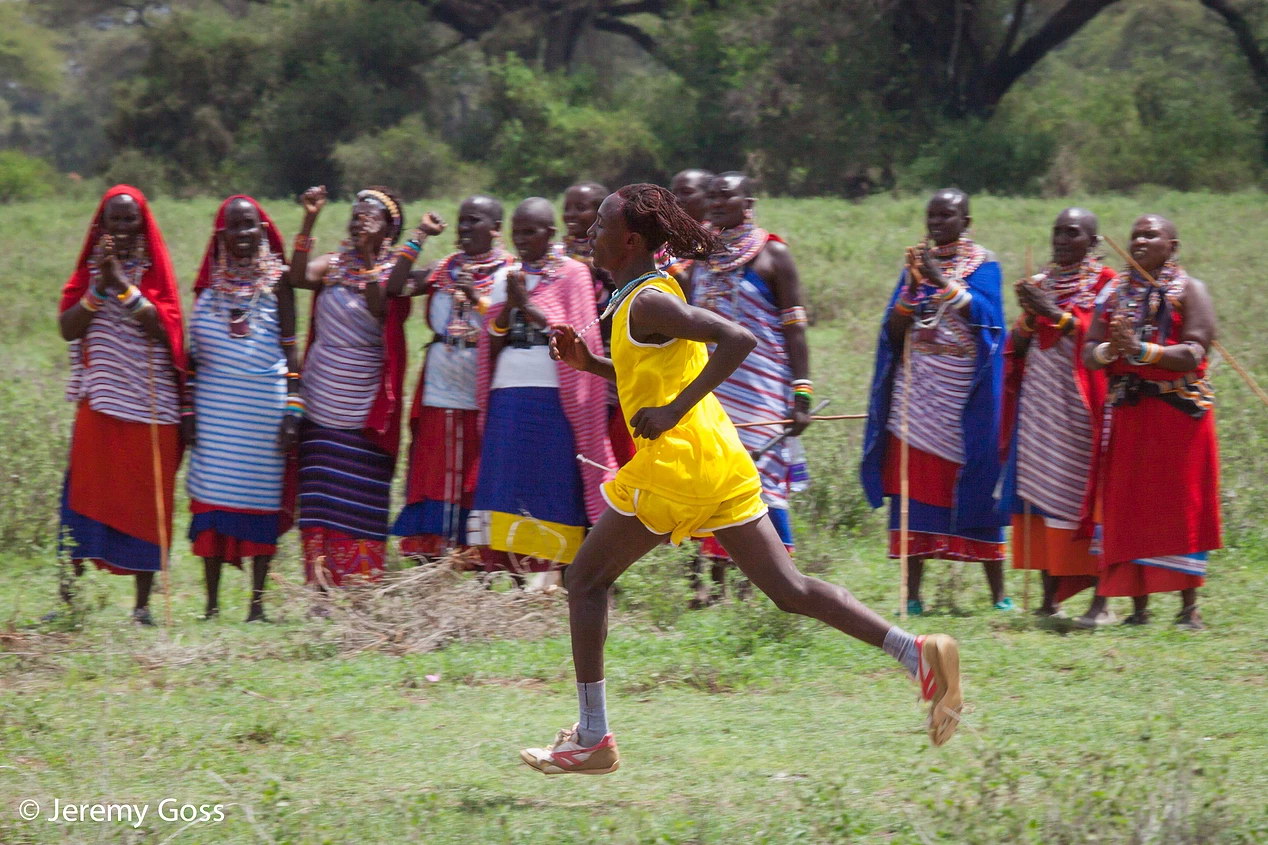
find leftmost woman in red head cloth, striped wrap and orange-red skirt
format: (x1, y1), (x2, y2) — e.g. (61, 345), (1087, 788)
(58, 185), (185, 626)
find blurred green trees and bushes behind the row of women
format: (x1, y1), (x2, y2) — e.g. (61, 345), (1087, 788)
(0, 0), (1268, 200)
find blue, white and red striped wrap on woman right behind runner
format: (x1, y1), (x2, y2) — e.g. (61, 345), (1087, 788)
(691, 263), (810, 509)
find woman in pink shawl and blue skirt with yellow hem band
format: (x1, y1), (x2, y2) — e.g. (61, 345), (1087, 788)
(476, 197), (614, 572)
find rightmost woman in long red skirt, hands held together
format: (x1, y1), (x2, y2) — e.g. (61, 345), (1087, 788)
(1083, 214), (1221, 631)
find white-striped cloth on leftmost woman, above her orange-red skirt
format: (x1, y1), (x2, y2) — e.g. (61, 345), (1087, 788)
(66, 297), (180, 425)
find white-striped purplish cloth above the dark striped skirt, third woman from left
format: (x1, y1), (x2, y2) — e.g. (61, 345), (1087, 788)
(303, 284), (383, 429)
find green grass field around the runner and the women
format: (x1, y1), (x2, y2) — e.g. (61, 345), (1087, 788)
(0, 193), (1268, 845)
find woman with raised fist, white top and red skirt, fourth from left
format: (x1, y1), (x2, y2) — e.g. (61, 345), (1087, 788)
(392, 195), (514, 557)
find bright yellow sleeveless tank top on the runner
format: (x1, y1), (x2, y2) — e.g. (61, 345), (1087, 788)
(611, 275), (761, 505)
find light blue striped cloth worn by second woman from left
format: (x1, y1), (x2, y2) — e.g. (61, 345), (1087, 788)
(186, 288), (287, 510)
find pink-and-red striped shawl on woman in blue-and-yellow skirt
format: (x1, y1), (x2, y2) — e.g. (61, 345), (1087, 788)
(476, 258), (616, 524)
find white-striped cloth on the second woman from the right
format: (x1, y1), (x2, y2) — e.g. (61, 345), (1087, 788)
(1017, 336), (1092, 523)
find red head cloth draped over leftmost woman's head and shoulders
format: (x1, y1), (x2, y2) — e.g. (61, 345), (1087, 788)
(57, 185), (186, 375)
